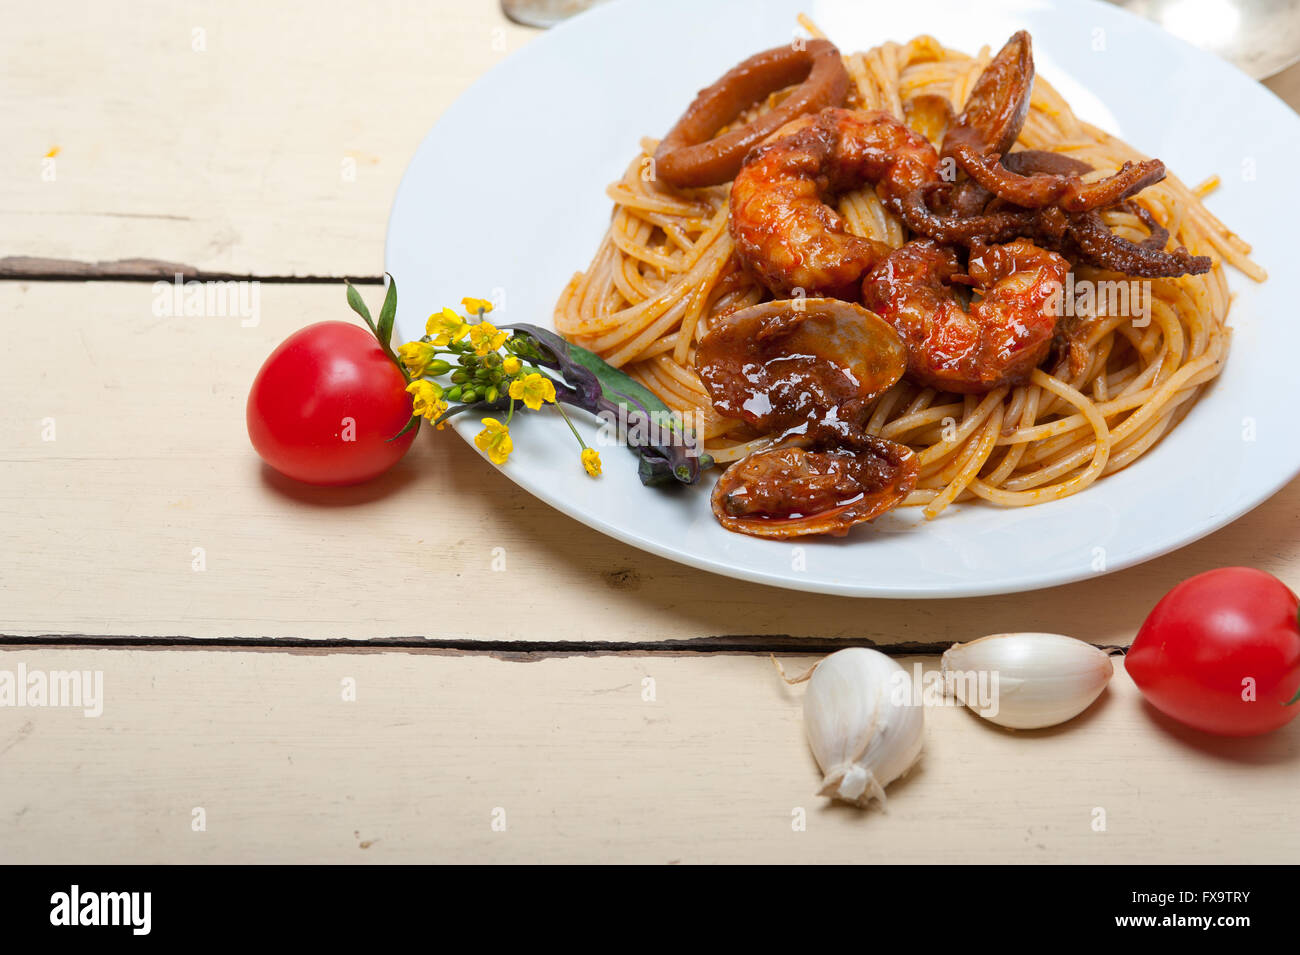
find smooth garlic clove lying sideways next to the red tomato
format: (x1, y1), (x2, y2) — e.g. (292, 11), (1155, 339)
(941, 633), (1114, 729)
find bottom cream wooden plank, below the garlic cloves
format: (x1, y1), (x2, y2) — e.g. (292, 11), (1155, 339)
(0, 648), (1300, 865)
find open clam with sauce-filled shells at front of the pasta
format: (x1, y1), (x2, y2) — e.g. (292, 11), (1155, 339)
(696, 299), (917, 538)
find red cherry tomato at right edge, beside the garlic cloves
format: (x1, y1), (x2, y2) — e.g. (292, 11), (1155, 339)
(1125, 567), (1300, 737)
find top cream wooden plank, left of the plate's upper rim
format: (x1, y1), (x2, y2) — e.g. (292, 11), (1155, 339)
(0, 0), (537, 277)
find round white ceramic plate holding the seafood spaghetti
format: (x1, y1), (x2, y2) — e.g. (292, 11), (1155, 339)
(386, 0), (1300, 598)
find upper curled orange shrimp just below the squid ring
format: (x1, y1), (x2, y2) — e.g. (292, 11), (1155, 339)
(731, 108), (939, 298)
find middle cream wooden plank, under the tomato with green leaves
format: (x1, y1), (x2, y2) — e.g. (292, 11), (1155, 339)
(0, 282), (1300, 647)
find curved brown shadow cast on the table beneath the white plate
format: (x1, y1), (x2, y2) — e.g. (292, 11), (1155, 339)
(434, 435), (1300, 652)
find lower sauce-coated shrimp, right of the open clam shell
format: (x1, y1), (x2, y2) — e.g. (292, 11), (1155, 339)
(862, 239), (1070, 394)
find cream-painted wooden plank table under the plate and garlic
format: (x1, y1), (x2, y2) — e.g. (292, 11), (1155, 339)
(0, 0), (1300, 863)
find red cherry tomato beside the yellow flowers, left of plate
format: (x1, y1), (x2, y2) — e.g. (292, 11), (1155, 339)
(248, 322), (416, 485)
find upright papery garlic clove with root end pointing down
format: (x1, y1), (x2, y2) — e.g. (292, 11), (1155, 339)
(803, 647), (926, 807)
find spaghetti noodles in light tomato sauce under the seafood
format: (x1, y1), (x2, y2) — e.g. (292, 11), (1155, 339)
(555, 29), (1265, 517)
